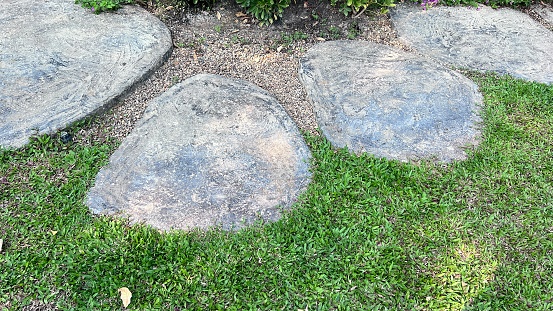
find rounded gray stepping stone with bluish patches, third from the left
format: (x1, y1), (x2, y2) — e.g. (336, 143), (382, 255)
(300, 41), (482, 162)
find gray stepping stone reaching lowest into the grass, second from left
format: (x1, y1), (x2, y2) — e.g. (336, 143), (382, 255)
(87, 74), (310, 230)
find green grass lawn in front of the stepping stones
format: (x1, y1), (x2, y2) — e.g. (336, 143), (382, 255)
(0, 74), (553, 311)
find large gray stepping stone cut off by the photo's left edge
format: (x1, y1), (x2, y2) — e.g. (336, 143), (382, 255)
(0, 0), (172, 147)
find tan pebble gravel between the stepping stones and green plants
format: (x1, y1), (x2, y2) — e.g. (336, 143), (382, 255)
(77, 0), (551, 143)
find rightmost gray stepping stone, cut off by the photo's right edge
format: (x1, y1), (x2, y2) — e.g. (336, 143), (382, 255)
(391, 4), (553, 84)
